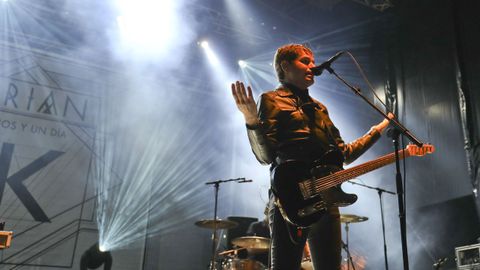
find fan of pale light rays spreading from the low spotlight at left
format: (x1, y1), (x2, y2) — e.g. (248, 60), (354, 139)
(96, 110), (214, 250)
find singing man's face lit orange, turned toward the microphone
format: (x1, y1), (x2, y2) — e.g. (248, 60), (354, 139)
(282, 50), (315, 89)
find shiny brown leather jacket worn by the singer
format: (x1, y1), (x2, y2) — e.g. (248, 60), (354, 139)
(247, 86), (380, 165)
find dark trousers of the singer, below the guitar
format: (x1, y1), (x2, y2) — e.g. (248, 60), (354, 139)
(269, 194), (342, 270)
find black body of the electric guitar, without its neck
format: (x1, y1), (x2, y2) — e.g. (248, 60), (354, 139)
(272, 151), (357, 227)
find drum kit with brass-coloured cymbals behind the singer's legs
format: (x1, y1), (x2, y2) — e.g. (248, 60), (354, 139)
(195, 214), (368, 270)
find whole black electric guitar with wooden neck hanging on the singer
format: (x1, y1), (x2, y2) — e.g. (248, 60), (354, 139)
(272, 144), (435, 227)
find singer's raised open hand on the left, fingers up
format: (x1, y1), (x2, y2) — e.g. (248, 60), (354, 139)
(232, 81), (259, 126)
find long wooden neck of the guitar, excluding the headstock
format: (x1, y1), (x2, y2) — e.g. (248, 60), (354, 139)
(314, 150), (410, 192)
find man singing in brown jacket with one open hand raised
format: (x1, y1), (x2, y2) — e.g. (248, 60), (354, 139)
(232, 44), (393, 270)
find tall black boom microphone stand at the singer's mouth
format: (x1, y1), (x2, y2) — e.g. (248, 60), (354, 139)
(325, 65), (423, 270)
